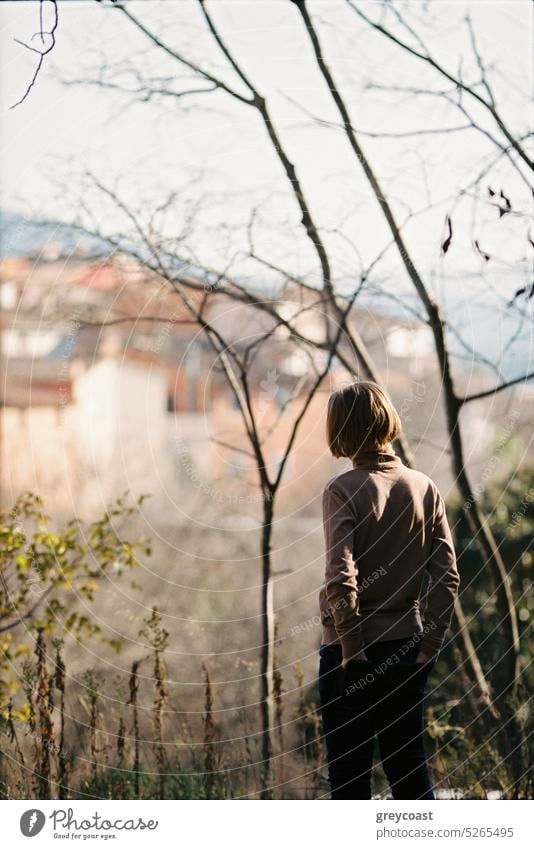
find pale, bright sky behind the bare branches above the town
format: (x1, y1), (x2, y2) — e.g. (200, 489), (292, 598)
(0, 0), (532, 374)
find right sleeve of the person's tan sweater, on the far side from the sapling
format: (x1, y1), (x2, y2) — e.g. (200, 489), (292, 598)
(421, 492), (460, 657)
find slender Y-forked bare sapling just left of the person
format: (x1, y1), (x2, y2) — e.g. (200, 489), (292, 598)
(62, 179), (366, 796)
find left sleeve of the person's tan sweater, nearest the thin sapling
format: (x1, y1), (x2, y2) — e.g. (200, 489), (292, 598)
(323, 484), (364, 662)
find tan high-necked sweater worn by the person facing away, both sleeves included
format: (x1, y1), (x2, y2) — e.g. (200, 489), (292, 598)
(319, 446), (460, 661)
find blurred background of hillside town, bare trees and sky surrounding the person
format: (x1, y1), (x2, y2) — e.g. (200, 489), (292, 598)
(0, 0), (534, 798)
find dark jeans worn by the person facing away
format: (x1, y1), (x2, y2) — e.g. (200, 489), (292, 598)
(319, 638), (435, 799)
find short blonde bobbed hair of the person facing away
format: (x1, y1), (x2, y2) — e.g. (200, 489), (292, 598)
(326, 380), (401, 457)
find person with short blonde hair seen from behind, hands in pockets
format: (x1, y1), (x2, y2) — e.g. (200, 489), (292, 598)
(319, 381), (460, 799)
